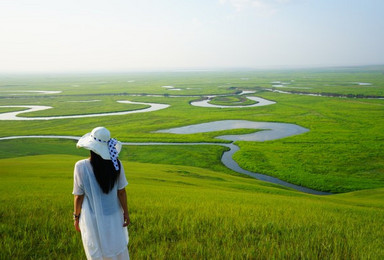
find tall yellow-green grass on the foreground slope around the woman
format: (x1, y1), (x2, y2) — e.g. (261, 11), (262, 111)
(0, 155), (384, 259)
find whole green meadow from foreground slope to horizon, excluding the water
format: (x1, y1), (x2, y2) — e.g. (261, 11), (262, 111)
(0, 66), (384, 259)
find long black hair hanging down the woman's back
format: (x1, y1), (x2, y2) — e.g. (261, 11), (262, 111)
(91, 151), (121, 194)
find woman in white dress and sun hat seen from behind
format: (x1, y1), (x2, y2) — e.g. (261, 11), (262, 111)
(72, 127), (130, 260)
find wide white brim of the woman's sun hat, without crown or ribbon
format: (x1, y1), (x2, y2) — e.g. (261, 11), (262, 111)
(76, 133), (122, 160)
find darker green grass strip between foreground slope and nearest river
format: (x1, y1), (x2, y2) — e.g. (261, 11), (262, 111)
(0, 138), (234, 176)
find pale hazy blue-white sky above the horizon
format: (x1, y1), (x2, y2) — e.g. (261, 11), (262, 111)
(0, 0), (384, 72)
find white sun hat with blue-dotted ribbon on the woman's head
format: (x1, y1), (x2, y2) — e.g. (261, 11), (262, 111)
(76, 127), (122, 170)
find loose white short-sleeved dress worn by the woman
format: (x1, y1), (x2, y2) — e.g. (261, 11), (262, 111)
(72, 159), (129, 260)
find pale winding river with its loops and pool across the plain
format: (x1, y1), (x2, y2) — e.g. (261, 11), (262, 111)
(0, 91), (330, 195)
